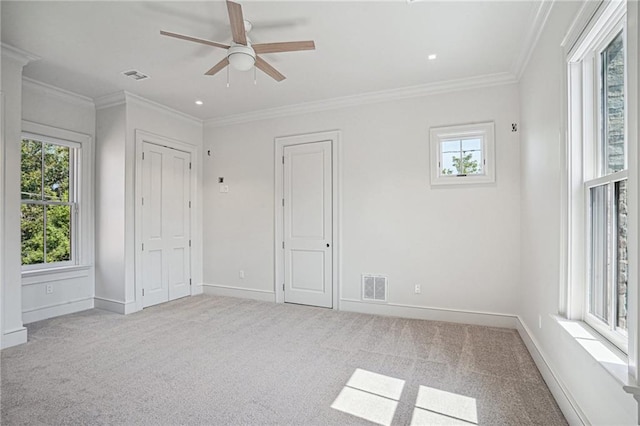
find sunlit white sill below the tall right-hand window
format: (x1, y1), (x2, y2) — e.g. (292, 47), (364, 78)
(551, 315), (636, 387)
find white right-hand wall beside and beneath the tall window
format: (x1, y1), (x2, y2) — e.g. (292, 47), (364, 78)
(519, 2), (637, 424)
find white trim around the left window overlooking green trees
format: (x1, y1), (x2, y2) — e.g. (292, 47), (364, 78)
(20, 120), (93, 277)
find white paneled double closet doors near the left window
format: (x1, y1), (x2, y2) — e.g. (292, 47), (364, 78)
(141, 142), (191, 307)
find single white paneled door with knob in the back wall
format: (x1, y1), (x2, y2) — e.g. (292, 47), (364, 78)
(283, 141), (333, 308)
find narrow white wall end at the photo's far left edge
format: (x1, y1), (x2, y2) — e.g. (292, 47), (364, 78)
(0, 46), (28, 348)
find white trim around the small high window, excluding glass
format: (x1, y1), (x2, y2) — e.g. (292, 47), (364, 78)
(429, 121), (495, 186)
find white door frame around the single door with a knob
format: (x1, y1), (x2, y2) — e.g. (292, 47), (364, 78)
(273, 130), (342, 310)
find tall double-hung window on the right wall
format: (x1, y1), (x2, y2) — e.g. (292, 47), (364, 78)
(569, 3), (628, 352)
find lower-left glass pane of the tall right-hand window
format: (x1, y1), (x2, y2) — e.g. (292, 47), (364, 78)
(589, 185), (609, 324)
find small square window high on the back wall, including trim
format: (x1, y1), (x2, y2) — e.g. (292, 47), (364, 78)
(430, 122), (495, 185)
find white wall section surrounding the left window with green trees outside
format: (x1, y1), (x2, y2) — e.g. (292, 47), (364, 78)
(22, 79), (95, 323)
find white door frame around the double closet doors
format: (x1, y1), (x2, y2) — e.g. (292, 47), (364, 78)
(134, 129), (202, 311)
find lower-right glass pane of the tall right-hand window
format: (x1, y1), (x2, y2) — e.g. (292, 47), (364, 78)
(615, 180), (629, 330)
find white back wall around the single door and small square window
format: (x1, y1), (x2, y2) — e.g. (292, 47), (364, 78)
(204, 85), (520, 322)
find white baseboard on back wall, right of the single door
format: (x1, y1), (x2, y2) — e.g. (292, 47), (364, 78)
(340, 299), (517, 328)
